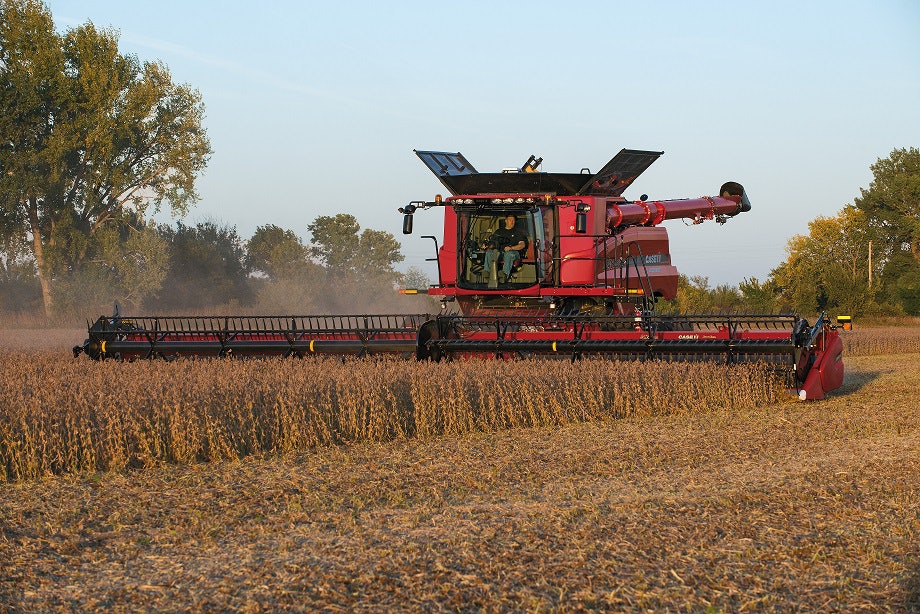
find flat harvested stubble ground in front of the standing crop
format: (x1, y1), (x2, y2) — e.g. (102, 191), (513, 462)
(0, 329), (920, 612)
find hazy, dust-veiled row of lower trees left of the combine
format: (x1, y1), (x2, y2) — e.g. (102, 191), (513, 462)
(0, 214), (427, 315)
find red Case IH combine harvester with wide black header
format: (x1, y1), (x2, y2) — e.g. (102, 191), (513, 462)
(74, 149), (843, 399)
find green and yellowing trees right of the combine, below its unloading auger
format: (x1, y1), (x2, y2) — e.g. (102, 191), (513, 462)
(666, 147), (920, 316)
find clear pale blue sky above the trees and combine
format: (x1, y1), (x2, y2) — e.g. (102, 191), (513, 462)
(48, 0), (920, 284)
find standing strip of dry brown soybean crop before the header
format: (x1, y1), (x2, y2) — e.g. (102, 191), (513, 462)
(0, 353), (784, 481)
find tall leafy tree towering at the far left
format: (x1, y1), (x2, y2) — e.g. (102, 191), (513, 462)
(0, 0), (211, 314)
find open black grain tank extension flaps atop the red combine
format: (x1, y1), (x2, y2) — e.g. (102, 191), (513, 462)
(415, 149), (663, 196)
